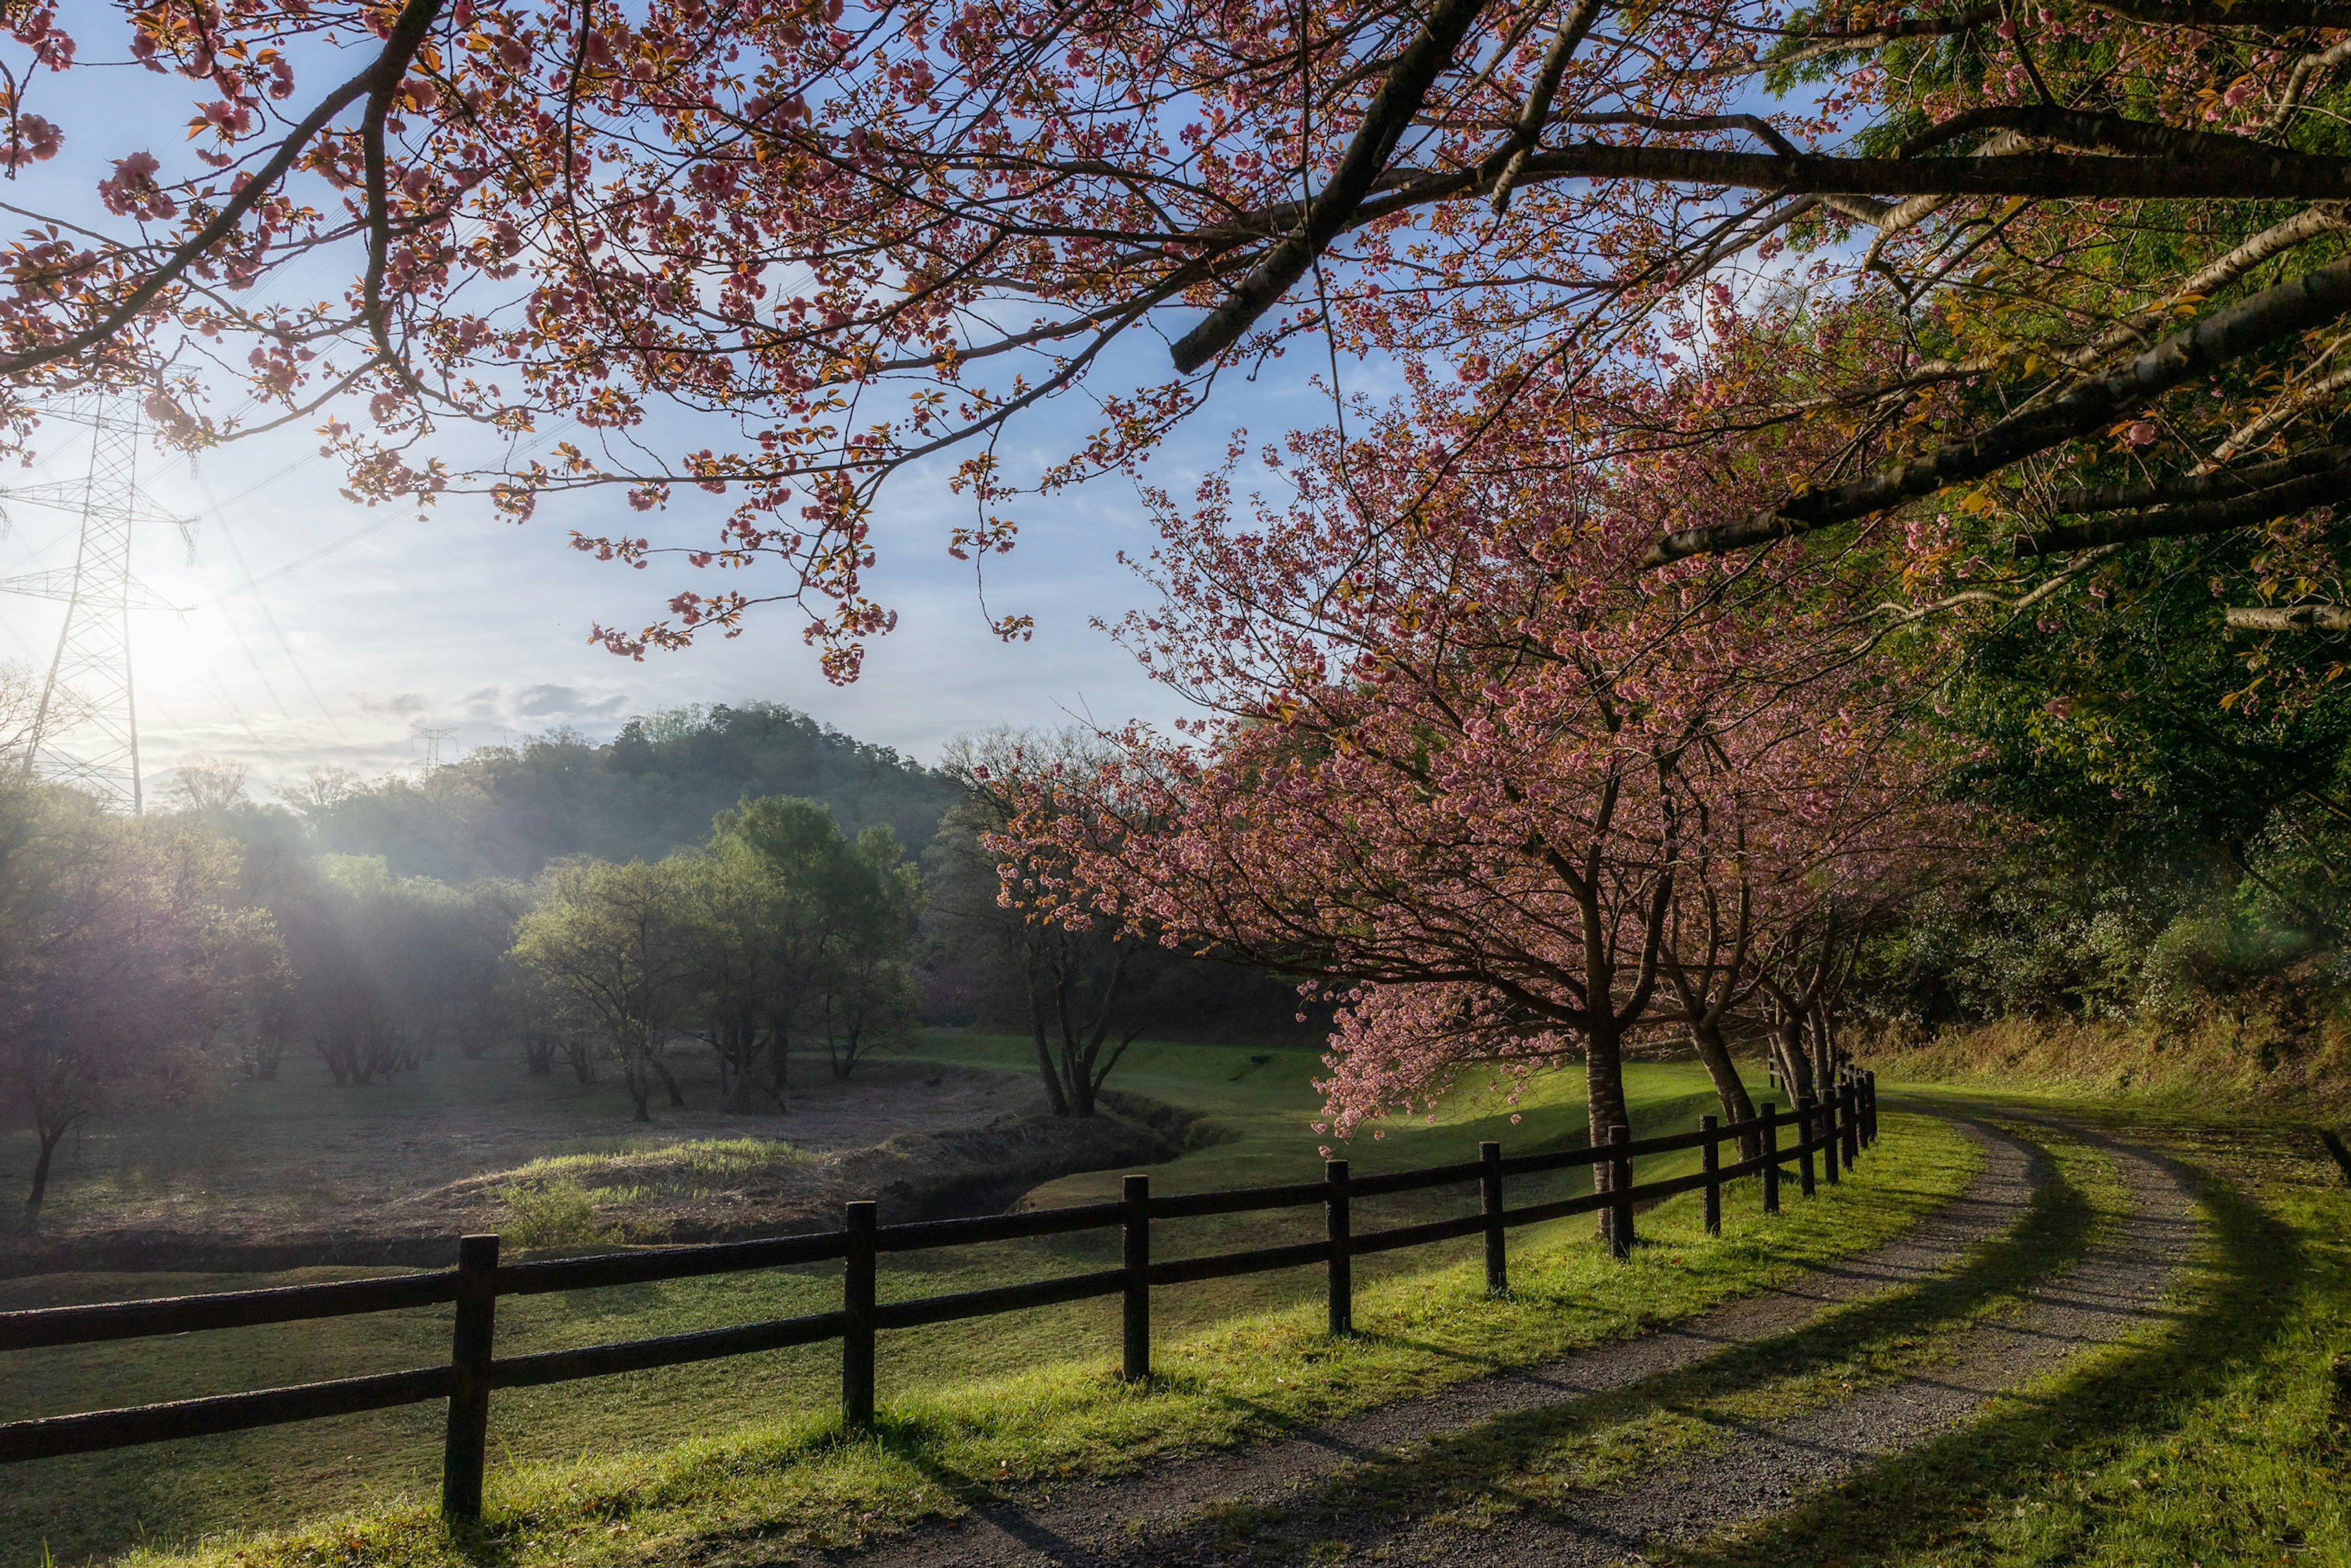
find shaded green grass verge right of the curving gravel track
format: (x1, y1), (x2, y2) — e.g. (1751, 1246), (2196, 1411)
(1674, 1095), (2351, 1568)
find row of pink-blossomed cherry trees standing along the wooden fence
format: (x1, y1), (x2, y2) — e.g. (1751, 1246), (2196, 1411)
(973, 388), (1970, 1171)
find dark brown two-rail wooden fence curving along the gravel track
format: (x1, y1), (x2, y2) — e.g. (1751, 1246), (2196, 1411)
(0, 1072), (1878, 1518)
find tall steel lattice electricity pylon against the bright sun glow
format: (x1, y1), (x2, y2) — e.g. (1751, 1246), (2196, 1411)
(0, 392), (195, 813)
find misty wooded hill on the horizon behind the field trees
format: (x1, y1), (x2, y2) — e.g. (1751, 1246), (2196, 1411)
(308, 703), (954, 882)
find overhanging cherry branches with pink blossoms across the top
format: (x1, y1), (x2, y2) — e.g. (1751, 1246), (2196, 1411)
(0, 0), (2351, 680)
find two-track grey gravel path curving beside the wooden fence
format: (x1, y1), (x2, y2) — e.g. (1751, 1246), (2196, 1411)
(818, 1121), (2078, 1568)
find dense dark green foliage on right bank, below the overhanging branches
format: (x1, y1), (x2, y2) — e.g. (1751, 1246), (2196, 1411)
(1862, 522), (2351, 1022)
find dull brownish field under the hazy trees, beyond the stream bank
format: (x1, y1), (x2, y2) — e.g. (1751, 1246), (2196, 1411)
(0, 1041), (1046, 1267)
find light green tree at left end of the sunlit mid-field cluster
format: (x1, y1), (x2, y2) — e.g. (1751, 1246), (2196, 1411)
(515, 860), (703, 1121)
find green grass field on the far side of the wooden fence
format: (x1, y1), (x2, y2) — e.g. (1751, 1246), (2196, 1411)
(0, 1034), (1777, 1561)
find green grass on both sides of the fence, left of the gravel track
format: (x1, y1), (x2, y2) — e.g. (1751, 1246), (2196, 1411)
(0, 1037), (1970, 1561)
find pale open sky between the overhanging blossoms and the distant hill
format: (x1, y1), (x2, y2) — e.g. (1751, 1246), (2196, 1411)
(0, 385), (1229, 787)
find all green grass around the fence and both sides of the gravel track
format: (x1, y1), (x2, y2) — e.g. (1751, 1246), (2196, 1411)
(18, 1034), (2351, 1568)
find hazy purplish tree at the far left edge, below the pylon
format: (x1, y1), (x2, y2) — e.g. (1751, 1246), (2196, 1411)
(0, 781), (285, 1215)
